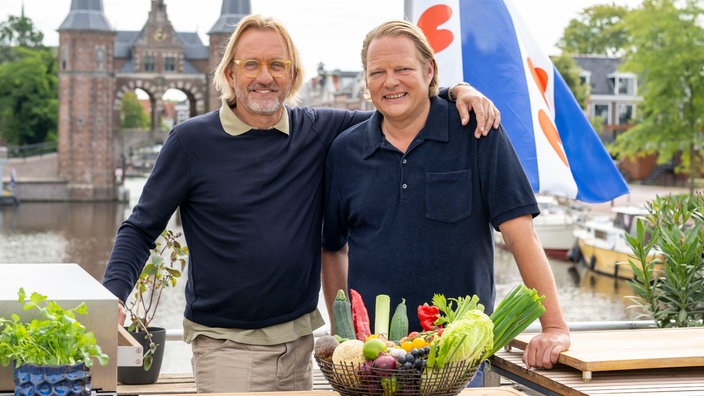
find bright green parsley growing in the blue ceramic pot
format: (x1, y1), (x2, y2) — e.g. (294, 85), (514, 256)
(0, 288), (108, 367)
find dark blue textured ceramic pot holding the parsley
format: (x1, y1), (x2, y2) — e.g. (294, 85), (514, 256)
(14, 363), (91, 396)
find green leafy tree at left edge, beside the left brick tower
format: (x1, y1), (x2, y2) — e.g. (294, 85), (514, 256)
(0, 47), (58, 145)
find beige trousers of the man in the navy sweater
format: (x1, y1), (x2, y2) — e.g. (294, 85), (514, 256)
(191, 335), (313, 393)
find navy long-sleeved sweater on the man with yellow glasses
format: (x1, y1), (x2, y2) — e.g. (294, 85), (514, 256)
(103, 108), (371, 329)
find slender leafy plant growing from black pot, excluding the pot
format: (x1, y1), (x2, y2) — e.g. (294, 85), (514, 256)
(125, 229), (188, 371)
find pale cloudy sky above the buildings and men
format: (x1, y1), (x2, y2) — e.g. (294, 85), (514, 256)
(0, 0), (640, 80)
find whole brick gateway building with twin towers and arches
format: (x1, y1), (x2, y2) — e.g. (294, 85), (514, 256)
(58, 0), (251, 201)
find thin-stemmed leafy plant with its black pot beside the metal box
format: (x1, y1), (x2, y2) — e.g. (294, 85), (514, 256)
(117, 229), (188, 384)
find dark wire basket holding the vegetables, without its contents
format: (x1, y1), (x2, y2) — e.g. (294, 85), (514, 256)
(315, 357), (479, 396)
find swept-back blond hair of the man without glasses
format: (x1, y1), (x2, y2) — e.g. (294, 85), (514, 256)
(362, 20), (439, 97)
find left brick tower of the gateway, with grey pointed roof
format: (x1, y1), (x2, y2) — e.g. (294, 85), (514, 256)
(58, 0), (116, 201)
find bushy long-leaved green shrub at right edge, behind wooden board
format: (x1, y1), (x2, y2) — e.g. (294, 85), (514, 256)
(626, 192), (704, 327)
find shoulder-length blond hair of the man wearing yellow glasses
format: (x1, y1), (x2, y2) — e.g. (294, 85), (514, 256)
(213, 15), (304, 105)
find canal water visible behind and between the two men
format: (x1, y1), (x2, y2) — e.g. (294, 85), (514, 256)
(0, 178), (636, 373)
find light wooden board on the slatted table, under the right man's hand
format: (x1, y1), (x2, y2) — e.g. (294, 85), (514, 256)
(509, 327), (704, 371)
